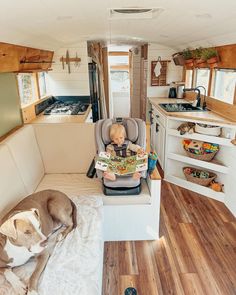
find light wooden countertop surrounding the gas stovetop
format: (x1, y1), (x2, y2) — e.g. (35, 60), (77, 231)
(30, 104), (91, 124)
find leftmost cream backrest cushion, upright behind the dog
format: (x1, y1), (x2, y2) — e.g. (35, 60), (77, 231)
(0, 144), (27, 217)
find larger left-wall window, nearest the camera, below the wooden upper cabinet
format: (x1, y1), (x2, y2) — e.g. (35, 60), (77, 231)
(17, 73), (37, 106)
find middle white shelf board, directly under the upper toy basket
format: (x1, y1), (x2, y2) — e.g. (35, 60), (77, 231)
(167, 153), (229, 174)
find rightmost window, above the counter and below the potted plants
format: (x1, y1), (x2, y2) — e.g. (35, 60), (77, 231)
(212, 69), (236, 104)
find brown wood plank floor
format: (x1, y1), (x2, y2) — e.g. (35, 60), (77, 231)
(103, 181), (236, 295)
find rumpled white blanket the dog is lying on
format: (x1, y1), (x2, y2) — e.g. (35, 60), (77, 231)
(0, 196), (103, 295)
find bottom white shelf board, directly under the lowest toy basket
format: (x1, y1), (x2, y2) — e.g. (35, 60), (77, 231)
(165, 175), (225, 202)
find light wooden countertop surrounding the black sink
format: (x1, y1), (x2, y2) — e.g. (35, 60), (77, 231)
(149, 97), (236, 126)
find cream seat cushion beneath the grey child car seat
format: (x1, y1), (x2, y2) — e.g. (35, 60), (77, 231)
(36, 174), (151, 205)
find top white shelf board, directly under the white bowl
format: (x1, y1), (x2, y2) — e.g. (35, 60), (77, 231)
(167, 129), (234, 147)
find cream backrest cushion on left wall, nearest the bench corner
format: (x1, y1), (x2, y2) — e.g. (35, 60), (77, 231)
(4, 126), (44, 194)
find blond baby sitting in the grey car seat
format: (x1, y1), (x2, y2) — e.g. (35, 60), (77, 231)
(103, 124), (145, 181)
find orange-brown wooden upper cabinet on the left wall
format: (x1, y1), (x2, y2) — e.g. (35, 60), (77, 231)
(0, 42), (54, 72)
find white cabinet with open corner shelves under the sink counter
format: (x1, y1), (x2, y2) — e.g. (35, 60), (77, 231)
(151, 100), (236, 215)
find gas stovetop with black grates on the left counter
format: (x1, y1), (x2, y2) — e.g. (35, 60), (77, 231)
(43, 101), (88, 115)
